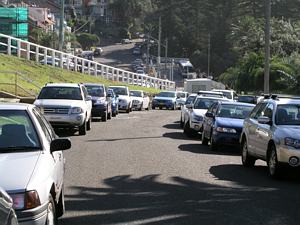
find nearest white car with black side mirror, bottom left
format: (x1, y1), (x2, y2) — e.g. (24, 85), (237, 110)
(0, 103), (71, 225)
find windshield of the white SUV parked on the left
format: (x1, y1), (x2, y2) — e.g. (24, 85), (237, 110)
(38, 87), (82, 100)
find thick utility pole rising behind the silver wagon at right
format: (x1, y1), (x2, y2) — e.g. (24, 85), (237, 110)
(264, 0), (271, 94)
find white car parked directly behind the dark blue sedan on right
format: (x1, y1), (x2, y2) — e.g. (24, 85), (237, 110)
(183, 95), (229, 137)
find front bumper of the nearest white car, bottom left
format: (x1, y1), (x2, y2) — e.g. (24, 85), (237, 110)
(16, 203), (48, 225)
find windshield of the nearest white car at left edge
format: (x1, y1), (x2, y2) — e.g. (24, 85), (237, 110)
(0, 110), (41, 153)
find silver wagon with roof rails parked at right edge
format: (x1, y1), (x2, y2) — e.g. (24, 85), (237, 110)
(241, 95), (300, 178)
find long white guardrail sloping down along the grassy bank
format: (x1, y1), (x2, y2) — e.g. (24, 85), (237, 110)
(0, 34), (175, 90)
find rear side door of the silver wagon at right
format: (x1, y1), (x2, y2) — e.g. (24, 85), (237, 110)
(245, 103), (267, 155)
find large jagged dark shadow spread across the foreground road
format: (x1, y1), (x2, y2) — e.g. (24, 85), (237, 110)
(60, 173), (300, 225)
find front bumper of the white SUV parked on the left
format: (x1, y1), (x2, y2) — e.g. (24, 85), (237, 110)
(45, 113), (85, 127)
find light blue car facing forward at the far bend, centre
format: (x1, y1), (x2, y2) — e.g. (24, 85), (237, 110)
(152, 91), (179, 110)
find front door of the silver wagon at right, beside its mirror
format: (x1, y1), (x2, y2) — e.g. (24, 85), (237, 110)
(255, 103), (274, 157)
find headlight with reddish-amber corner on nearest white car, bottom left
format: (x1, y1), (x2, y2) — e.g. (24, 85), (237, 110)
(10, 191), (41, 210)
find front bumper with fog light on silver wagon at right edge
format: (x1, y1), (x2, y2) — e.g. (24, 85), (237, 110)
(277, 146), (300, 167)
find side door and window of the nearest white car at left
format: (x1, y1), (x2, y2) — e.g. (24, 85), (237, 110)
(33, 109), (65, 195)
